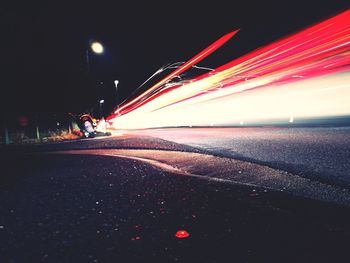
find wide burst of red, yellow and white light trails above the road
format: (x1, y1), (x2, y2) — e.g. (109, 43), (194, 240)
(108, 10), (350, 129)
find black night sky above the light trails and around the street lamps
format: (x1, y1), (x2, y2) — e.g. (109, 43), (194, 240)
(0, 0), (350, 114)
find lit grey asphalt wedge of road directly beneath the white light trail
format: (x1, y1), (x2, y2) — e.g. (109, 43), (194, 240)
(127, 126), (350, 186)
